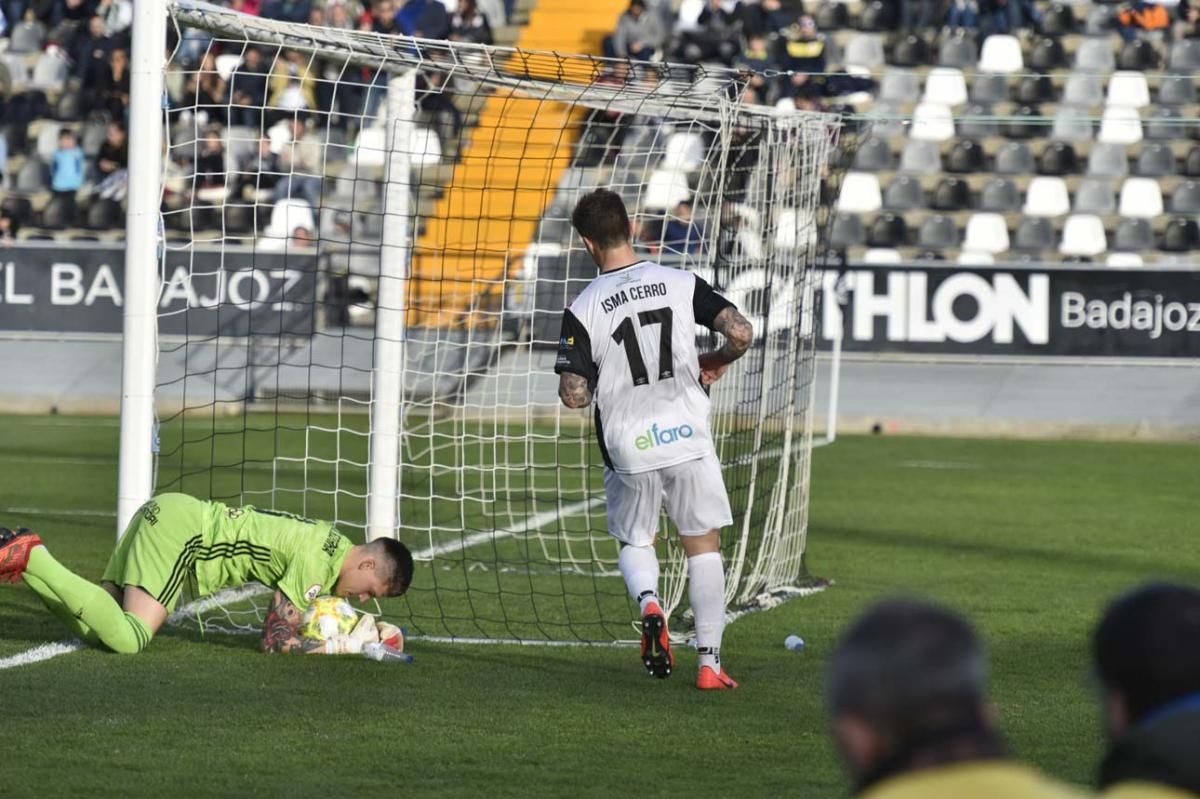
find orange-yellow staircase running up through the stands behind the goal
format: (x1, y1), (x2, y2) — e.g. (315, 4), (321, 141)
(409, 0), (629, 326)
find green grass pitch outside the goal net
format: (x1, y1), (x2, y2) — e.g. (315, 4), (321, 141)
(0, 416), (1200, 797)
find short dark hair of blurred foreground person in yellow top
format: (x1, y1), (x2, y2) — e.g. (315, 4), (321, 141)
(826, 600), (988, 750)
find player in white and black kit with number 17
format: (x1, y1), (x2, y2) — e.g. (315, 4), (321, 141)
(554, 188), (754, 690)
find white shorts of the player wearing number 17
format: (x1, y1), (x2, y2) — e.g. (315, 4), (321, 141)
(604, 452), (733, 547)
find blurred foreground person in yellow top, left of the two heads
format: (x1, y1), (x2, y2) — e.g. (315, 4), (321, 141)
(826, 600), (1082, 799)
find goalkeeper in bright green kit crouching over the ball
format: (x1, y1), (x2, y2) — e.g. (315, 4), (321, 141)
(0, 494), (413, 654)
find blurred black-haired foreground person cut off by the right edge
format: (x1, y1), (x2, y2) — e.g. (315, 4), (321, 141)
(1092, 583), (1200, 799)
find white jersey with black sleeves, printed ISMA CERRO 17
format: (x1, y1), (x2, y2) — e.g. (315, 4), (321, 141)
(554, 260), (732, 474)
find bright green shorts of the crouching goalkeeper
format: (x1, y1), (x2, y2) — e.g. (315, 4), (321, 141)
(101, 494), (206, 611)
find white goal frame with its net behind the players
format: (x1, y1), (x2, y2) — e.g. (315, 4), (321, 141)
(118, 0), (842, 643)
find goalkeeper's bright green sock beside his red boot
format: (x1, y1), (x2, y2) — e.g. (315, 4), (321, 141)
(25, 547), (152, 655)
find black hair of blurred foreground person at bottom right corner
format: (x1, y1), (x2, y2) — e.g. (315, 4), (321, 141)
(1092, 583), (1200, 723)
